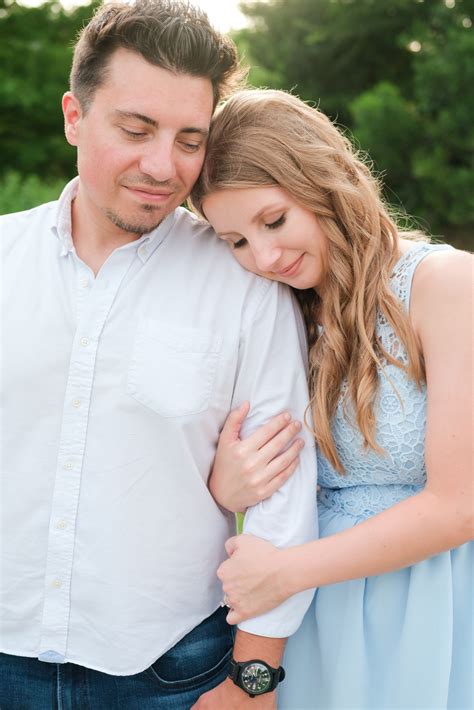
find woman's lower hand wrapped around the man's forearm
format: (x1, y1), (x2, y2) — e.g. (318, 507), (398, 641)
(217, 534), (291, 624)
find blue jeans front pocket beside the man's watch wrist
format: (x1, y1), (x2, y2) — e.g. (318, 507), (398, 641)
(147, 609), (234, 690)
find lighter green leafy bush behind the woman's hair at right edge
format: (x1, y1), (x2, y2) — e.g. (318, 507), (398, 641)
(351, 3), (474, 234)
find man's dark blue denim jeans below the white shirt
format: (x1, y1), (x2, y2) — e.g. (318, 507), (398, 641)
(0, 609), (233, 710)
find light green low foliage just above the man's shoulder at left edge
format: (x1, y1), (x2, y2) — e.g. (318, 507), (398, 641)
(0, 172), (64, 214)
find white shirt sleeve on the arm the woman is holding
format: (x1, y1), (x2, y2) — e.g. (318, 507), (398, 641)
(234, 283), (318, 638)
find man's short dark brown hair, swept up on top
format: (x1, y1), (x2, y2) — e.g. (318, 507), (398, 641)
(70, 0), (243, 111)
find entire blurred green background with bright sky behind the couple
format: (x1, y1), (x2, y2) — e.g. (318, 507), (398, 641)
(0, 0), (474, 250)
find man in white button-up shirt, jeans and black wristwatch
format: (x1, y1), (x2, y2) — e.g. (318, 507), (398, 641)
(0, 0), (315, 710)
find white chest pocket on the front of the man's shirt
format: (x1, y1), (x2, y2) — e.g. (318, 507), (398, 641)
(126, 318), (222, 417)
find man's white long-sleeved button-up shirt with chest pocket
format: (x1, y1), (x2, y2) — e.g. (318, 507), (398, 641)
(0, 179), (316, 675)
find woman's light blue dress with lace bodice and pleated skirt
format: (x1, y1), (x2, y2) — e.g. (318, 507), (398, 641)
(278, 243), (474, 710)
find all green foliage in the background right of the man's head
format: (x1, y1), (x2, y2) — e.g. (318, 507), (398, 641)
(235, 0), (474, 248)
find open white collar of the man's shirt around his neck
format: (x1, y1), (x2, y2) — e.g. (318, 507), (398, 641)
(52, 177), (176, 263)
